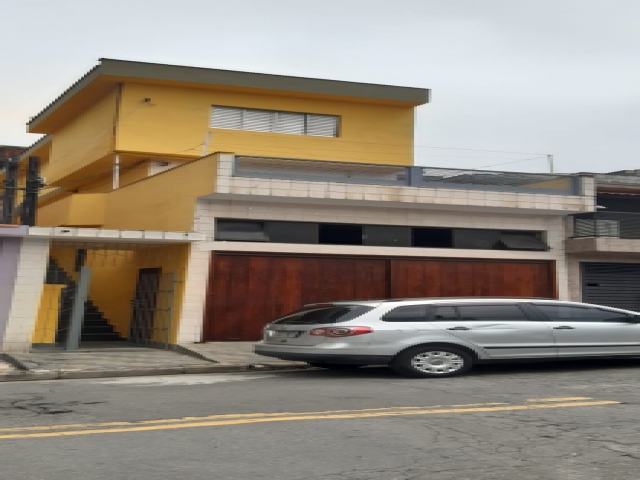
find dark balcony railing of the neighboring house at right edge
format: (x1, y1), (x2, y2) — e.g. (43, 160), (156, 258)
(572, 212), (640, 239)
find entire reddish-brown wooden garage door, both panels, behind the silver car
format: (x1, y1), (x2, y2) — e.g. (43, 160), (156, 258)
(204, 253), (555, 341)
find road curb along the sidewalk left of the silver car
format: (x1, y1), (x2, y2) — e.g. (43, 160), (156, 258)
(0, 363), (311, 382)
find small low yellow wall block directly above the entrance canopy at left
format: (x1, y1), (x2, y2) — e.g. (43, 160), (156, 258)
(36, 193), (105, 227)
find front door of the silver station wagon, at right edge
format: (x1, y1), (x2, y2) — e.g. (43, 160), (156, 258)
(533, 303), (640, 357)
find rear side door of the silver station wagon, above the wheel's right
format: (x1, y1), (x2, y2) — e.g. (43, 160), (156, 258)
(431, 303), (557, 358)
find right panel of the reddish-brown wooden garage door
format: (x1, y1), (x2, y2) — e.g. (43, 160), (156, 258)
(391, 259), (556, 298)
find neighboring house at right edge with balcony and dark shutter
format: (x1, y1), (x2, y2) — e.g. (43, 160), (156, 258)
(566, 170), (640, 311)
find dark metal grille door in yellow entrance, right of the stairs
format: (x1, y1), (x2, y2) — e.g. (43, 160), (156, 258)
(129, 268), (162, 341)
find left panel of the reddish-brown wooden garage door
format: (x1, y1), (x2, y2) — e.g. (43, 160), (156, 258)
(204, 254), (387, 341)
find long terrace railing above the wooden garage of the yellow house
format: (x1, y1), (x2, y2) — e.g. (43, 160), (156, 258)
(233, 156), (581, 195)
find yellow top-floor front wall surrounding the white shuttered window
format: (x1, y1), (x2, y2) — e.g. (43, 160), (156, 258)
(116, 84), (414, 165)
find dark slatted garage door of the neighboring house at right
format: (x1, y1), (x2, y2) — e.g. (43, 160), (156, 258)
(582, 263), (640, 311)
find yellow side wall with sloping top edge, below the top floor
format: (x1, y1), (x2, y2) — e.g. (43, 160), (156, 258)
(104, 156), (217, 231)
